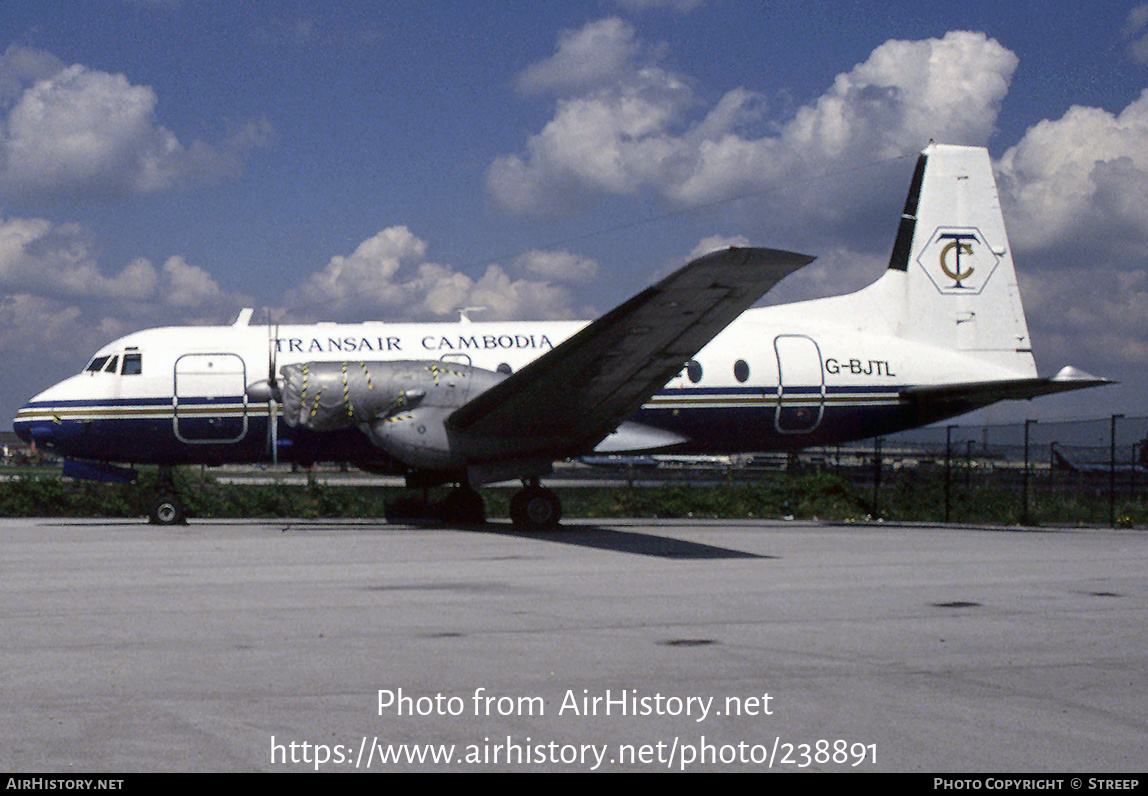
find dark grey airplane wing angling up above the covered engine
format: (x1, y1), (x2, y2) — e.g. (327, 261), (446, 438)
(447, 248), (813, 458)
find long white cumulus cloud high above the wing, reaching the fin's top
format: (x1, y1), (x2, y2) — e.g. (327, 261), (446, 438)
(487, 20), (1017, 216)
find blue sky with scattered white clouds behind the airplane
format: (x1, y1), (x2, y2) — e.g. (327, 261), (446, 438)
(0, 0), (1148, 418)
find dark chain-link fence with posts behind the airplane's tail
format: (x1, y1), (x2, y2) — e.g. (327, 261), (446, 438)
(808, 415), (1148, 526)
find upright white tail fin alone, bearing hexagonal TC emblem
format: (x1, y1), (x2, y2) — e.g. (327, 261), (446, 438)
(863, 144), (1035, 376)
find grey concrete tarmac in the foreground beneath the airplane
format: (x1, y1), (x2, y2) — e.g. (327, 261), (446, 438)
(0, 519), (1148, 771)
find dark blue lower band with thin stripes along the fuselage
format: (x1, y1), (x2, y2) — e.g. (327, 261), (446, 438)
(14, 386), (915, 464)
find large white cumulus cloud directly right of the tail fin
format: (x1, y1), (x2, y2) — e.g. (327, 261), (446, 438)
(996, 92), (1148, 370)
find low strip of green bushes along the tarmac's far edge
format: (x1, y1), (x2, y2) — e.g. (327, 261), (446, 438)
(0, 469), (1148, 527)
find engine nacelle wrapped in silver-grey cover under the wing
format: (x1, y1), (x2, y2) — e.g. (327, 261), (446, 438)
(280, 360), (506, 470)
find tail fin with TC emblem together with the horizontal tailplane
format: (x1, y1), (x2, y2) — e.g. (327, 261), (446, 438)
(790, 144), (1111, 404)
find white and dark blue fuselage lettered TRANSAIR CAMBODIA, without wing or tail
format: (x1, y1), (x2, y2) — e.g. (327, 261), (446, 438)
(15, 302), (1024, 469)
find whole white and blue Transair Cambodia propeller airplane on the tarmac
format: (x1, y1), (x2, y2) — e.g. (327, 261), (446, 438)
(14, 144), (1110, 528)
